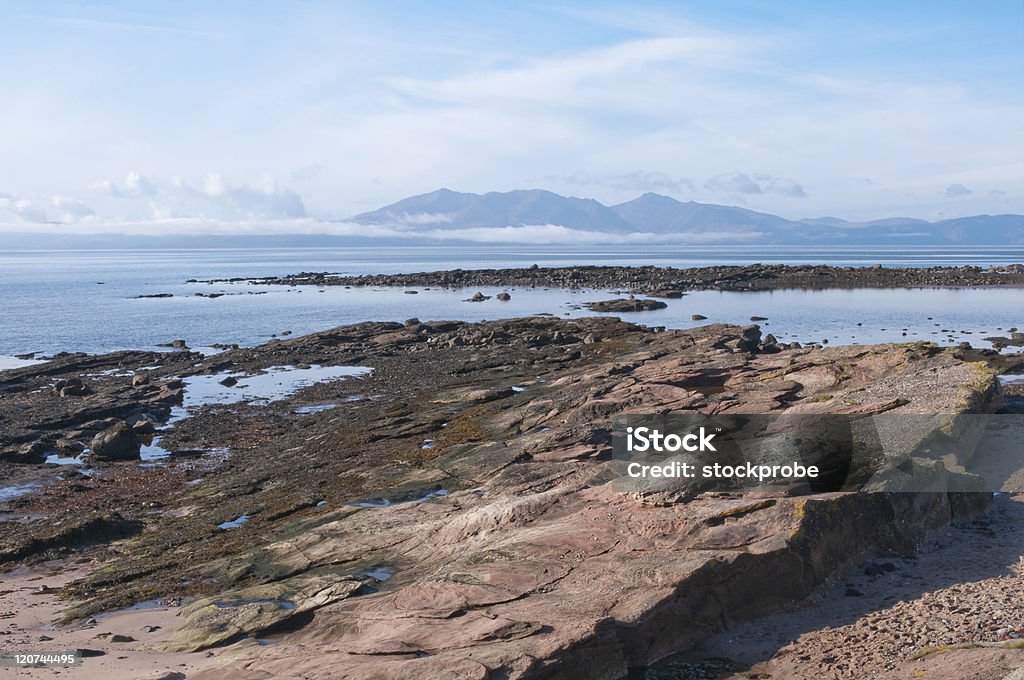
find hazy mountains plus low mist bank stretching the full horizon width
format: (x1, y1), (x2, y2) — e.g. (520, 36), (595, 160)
(0, 188), (1024, 250)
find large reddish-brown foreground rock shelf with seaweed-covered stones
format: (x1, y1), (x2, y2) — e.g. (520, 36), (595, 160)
(0, 319), (1024, 680)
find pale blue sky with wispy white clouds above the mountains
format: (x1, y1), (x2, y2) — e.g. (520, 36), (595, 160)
(0, 0), (1024, 233)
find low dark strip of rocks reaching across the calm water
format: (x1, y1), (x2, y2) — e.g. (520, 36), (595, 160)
(199, 264), (1024, 297)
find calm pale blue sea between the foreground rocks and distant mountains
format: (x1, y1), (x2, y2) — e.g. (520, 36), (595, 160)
(0, 244), (1024, 360)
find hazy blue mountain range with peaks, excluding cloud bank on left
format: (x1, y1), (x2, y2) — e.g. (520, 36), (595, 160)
(351, 188), (1024, 245)
